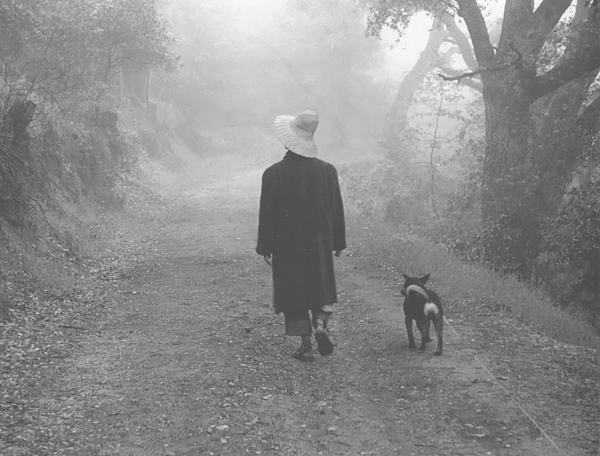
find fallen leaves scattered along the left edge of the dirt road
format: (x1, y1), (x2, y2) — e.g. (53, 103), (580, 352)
(0, 176), (173, 454)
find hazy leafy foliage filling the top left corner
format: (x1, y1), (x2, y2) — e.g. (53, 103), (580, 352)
(0, 0), (176, 108)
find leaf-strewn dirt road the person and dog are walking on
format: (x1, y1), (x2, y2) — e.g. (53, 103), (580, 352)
(7, 151), (598, 456)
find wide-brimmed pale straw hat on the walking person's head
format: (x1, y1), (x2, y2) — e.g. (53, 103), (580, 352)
(275, 111), (319, 158)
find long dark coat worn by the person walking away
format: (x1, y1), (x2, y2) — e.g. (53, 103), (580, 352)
(256, 151), (346, 313)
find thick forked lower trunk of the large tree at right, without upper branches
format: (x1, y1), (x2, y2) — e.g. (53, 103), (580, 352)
(482, 69), (594, 280)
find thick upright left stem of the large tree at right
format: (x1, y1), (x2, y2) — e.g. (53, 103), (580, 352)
(482, 70), (541, 279)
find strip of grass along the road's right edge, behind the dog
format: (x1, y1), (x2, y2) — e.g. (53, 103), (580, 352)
(347, 210), (600, 350)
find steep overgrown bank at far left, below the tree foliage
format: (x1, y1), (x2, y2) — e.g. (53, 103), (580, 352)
(0, 110), (134, 317)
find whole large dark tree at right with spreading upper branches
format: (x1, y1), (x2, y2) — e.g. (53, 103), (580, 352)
(368, 0), (600, 278)
